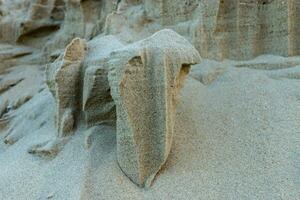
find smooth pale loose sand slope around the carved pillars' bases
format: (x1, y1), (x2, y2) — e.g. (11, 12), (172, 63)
(0, 57), (300, 200)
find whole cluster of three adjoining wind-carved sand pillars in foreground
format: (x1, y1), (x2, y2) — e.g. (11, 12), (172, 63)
(47, 30), (200, 186)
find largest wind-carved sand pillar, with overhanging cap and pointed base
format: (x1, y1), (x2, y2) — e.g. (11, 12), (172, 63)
(108, 30), (200, 187)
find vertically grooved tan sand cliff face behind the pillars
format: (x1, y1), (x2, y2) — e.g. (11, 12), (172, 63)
(0, 0), (300, 59)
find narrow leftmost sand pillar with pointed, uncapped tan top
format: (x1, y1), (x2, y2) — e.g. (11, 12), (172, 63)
(46, 38), (86, 137)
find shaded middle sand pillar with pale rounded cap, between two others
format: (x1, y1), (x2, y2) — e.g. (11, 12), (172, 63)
(82, 35), (124, 127)
